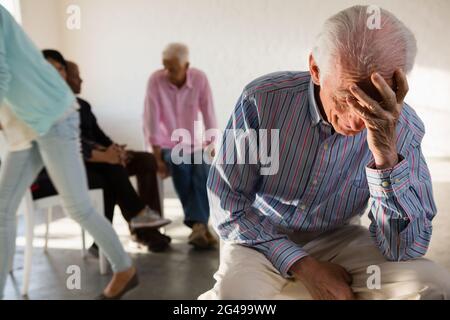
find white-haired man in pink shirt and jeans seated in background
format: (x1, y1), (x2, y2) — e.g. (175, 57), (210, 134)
(143, 43), (217, 248)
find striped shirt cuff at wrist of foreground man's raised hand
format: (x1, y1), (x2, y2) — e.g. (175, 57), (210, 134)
(366, 157), (410, 198)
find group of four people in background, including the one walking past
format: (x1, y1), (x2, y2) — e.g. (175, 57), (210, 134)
(0, 6), (217, 299)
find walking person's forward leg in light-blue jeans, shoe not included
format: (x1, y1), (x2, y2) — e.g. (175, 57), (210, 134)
(37, 112), (132, 273)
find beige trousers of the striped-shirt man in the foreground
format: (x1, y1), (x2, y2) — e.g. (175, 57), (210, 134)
(199, 225), (450, 300)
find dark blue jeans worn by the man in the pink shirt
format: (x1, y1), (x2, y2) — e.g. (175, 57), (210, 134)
(162, 149), (210, 227)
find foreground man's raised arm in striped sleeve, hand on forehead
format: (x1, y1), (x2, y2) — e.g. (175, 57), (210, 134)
(347, 69), (436, 260)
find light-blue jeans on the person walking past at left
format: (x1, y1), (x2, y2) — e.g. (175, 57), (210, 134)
(0, 111), (131, 298)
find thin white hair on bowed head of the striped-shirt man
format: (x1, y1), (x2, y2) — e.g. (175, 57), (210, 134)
(312, 6), (417, 81)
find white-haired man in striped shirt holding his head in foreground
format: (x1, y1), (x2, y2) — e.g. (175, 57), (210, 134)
(200, 6), (450, 299)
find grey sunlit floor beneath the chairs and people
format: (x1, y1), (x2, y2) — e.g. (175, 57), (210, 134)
(5, 160), (450, 299)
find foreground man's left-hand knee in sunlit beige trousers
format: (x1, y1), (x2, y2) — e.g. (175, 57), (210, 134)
(198, 243), (288, 300)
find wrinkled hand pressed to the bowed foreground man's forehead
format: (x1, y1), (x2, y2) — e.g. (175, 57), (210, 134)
(347, 69), (408, 169)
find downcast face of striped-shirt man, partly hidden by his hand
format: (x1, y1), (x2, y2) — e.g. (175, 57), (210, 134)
(311, 54), (393, 136)
